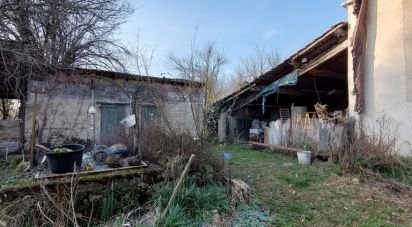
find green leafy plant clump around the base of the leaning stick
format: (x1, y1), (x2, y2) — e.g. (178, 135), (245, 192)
(151, 176), (229, 226)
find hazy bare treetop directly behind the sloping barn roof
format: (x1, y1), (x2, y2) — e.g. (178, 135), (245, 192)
(231, 47), (281, 90)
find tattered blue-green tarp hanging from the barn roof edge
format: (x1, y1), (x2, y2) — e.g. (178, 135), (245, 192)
(256, 70), (298, 113)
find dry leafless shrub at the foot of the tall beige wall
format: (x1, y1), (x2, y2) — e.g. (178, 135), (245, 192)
(331, 116), (411, 177)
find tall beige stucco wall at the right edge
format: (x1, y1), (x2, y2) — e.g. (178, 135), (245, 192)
(348, 0), (412, 155)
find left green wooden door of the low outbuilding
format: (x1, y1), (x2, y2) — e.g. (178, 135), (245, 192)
(100, 104), (126, 146)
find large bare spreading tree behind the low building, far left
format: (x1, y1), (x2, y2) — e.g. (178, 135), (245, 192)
(0, 0), (133, 90)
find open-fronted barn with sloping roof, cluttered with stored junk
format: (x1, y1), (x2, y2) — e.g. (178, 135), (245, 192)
(216, 22), (348, 154)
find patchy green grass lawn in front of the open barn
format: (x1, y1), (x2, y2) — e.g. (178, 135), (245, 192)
(219, 145), (412, 226)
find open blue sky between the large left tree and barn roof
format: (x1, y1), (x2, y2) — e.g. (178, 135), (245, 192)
(117, 0), (347, 76)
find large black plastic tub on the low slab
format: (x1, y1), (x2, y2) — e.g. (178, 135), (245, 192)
(46, 144), (85, 173)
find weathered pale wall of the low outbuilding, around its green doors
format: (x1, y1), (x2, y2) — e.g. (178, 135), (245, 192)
(25, 74), (202, 143)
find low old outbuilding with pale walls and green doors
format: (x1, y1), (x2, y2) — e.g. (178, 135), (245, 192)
(1, 66), (203, 153)
